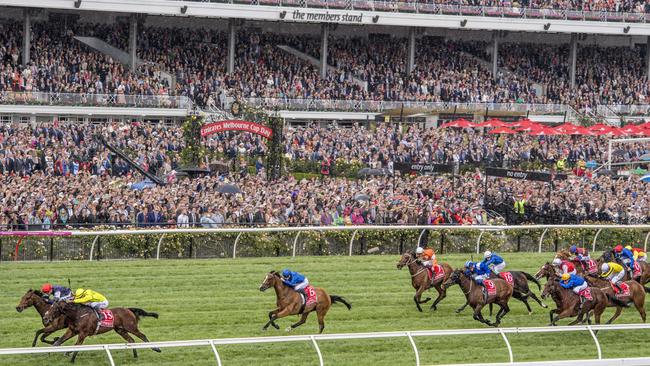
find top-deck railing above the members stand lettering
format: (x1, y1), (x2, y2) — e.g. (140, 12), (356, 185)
(181, 0), (649, 23)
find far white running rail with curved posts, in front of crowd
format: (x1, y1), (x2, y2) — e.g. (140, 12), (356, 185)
(0, 224), (650, 261)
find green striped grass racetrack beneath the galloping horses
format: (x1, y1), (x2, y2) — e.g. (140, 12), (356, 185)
(0, 253), (650, 366)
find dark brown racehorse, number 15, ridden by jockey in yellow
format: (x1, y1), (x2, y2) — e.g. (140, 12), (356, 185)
(43, 301), (161, 362)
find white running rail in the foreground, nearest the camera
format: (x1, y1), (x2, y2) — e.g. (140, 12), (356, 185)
(0, 324), (650, 366)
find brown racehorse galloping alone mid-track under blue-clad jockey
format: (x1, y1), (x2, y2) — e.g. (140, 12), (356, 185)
(260, 271), (352, 333)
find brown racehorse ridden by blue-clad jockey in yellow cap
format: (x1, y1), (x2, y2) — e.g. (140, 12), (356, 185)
(542, 278), (625, 325)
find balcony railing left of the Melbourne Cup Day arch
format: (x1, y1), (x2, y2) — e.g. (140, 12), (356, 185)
(0, 91), (193, 109)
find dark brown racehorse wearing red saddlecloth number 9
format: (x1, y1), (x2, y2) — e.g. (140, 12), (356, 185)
(444, 269), (512, 327)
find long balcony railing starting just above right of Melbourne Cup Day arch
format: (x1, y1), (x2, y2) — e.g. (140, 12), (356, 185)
(244, 98), (575, 116)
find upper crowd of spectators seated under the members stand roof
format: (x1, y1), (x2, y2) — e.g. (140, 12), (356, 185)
(0, 20), (650, 109)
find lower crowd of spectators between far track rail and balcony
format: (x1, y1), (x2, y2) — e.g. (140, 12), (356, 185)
(0, 124), (650, 229)
